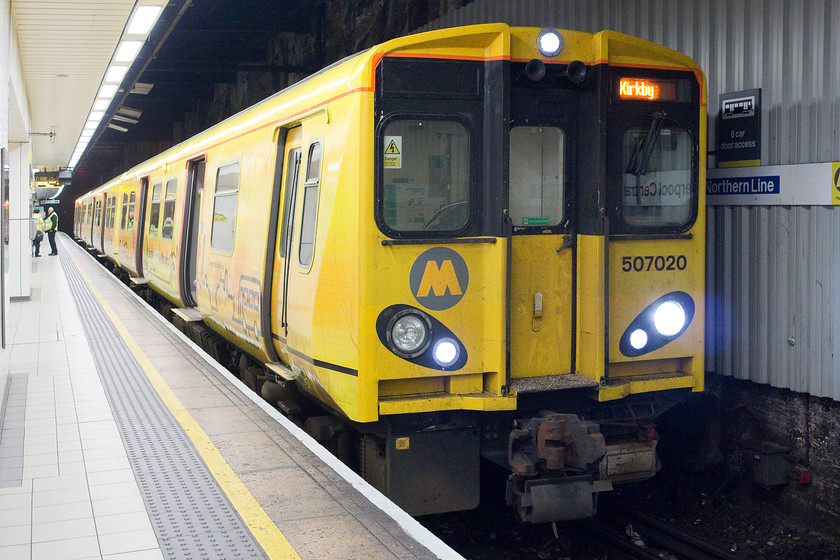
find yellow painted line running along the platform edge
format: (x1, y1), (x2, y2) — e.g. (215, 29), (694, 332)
(68, 252), (300, 560)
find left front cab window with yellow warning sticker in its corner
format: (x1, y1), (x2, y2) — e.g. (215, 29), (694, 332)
(380, 119), (471, 235)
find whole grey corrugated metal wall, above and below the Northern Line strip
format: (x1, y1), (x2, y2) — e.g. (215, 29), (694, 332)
(424, 0), (840, 400)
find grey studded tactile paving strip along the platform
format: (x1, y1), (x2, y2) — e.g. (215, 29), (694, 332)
(60, 251), (265, 559)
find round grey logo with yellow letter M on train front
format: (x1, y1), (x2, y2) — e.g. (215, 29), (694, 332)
(408, 247), (470, 311)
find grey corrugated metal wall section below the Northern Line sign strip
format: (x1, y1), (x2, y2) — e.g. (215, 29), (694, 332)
(706, 206), (840, 400)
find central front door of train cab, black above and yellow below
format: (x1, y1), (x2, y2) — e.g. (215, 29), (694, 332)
(508, 88), (575, 379)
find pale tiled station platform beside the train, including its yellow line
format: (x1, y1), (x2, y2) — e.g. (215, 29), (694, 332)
(0, 234), (461, 560)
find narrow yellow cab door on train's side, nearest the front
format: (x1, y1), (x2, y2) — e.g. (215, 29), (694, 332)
(271, 127), (302, 343)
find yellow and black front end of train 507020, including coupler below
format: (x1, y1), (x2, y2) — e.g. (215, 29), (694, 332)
(362, 26), (706, 522)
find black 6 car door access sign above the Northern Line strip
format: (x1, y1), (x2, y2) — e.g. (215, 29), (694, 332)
(717, 89), (761, 167)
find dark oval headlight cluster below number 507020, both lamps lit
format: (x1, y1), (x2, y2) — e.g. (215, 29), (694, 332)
(618, 292), (694, 358)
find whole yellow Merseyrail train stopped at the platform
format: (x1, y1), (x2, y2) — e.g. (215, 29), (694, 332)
(75, 24), (706, 522)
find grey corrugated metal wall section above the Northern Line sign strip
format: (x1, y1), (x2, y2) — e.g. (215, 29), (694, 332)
(421, 0), (840, 165)
